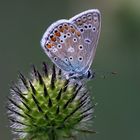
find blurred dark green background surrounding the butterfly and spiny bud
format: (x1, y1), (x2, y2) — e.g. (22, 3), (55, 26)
(0, 0), (140, 140)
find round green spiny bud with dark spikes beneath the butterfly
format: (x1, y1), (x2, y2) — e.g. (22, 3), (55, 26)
(8, 63), (93, 140)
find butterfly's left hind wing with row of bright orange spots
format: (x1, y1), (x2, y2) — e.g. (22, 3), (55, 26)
(41, 20), (88, 73)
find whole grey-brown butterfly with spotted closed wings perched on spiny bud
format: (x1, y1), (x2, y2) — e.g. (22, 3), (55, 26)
(41, 9), (101, 79)
